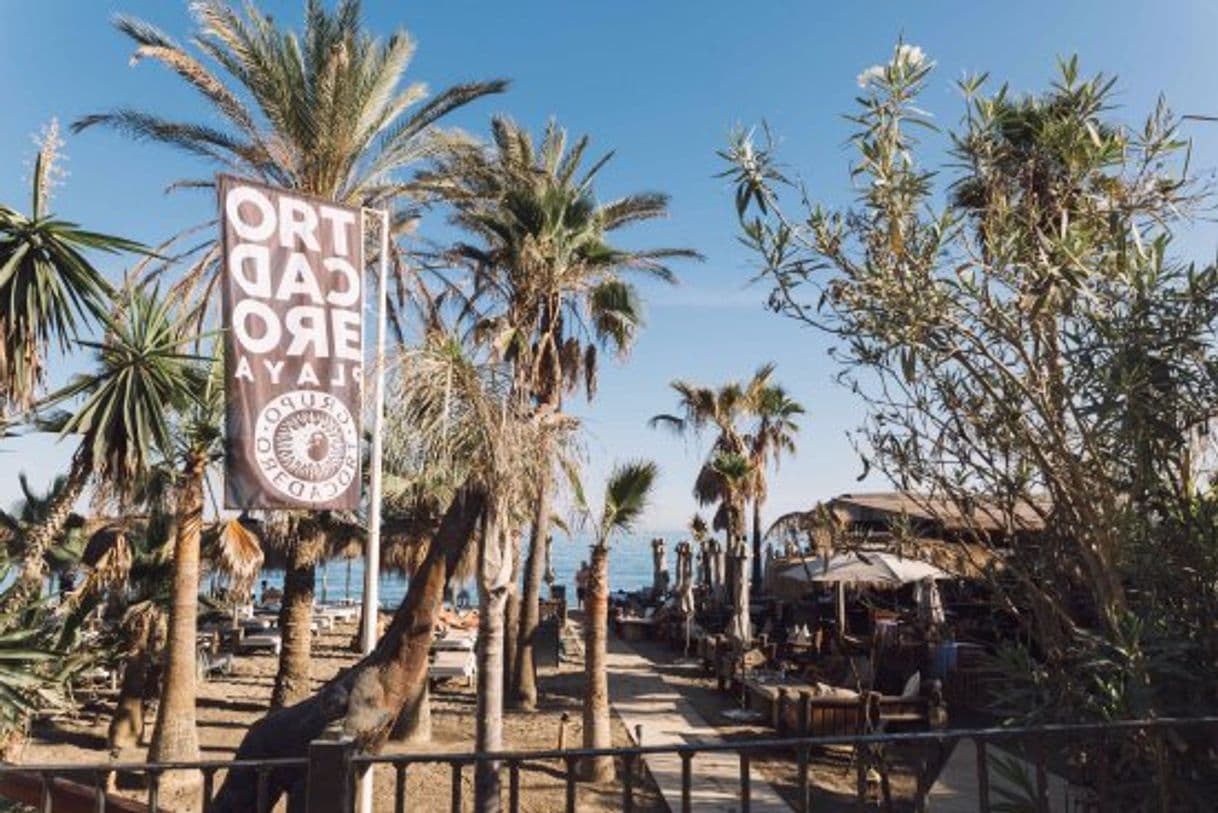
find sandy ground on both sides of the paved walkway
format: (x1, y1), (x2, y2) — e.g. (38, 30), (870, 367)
(21, 616), (917, 813)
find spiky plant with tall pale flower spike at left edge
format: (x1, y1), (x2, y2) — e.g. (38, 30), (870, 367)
(0, 119), (140, 414)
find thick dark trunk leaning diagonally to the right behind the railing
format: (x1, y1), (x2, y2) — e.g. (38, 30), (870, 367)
(213, 486), (486, 813)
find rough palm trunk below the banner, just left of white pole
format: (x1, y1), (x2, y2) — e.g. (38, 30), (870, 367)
(270, 539), (319, 709)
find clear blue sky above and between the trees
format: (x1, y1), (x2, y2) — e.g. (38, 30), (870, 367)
(0, 0), (1218, 530)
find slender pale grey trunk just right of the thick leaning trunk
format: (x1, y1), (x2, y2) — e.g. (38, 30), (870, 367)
(474, 522), (506, 813)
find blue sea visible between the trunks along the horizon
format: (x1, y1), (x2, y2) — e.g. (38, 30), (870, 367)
(255, 531), (688, 611)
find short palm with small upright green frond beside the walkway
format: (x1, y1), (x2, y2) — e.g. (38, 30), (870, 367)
(574, 461), (659, 781)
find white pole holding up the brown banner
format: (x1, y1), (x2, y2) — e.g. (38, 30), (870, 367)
(359, 204), (389, 813)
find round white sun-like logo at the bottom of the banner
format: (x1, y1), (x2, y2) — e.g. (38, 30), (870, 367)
(253, 390), (359, 503)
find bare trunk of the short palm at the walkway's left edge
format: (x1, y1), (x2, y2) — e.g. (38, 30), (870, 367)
(581, 544), (614, 783)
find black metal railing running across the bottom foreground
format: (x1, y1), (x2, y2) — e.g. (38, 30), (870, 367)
(0, 717), (1218, 813)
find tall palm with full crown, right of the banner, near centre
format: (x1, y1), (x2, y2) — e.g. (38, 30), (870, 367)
(420, 117), (698, 708)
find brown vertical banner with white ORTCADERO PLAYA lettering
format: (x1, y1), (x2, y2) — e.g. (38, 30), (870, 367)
(217, 176), (364, 509)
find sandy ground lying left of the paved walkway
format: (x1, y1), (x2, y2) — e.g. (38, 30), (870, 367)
(21, 624), (665, 813)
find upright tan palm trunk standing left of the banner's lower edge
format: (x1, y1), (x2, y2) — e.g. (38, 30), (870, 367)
(149, 456), (207, 762)
